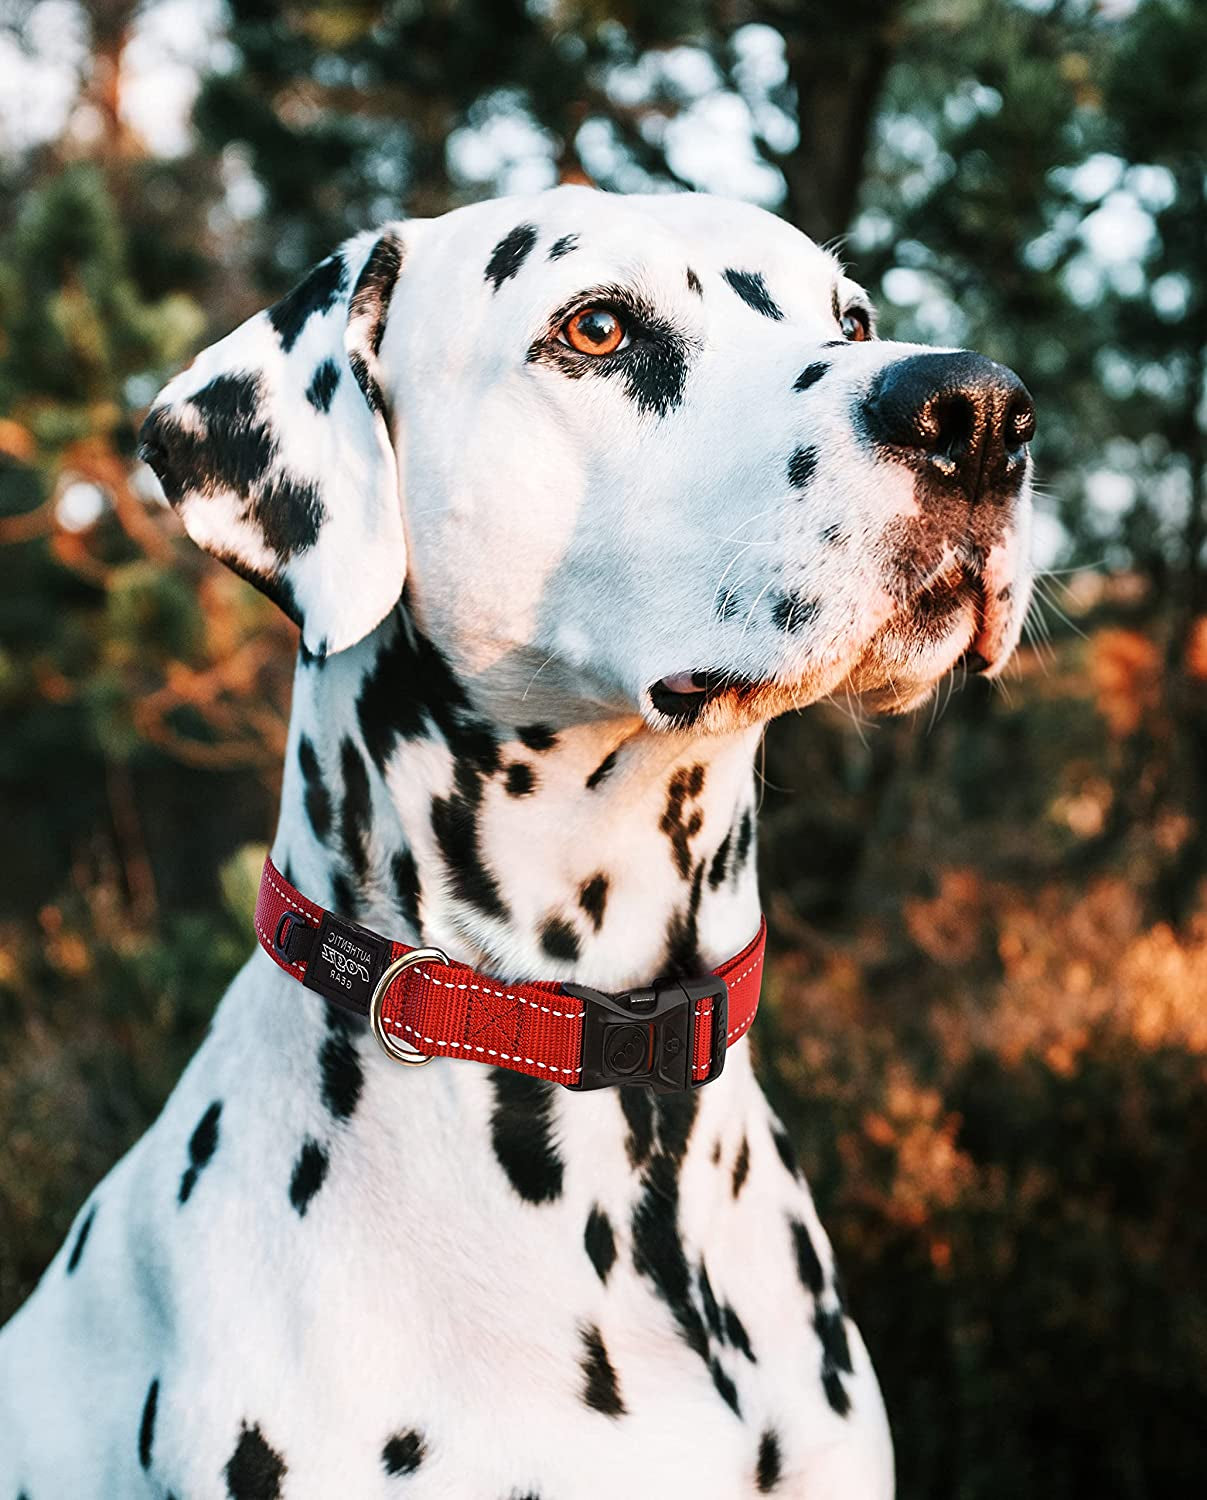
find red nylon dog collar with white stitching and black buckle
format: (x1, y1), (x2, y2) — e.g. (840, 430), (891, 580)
(255, 860), (766, 1092)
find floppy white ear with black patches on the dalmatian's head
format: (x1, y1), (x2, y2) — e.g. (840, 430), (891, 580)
(139, 225), (408, 656)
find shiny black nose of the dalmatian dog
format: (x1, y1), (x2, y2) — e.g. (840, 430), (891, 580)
(862, 351), (1035, 501)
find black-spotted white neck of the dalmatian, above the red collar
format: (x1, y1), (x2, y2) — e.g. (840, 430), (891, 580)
(273, 606), (759, 1008)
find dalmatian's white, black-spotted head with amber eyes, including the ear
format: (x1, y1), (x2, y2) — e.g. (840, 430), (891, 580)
(142, 188), (1035, 731)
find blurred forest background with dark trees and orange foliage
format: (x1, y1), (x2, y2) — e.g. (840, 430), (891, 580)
(0, 0), (1207, 1500)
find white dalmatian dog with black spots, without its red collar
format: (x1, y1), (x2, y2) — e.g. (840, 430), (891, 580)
(0, 188), (1035, 1500)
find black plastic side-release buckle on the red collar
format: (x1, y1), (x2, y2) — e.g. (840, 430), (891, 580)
(562, 975), (729, 1094)
